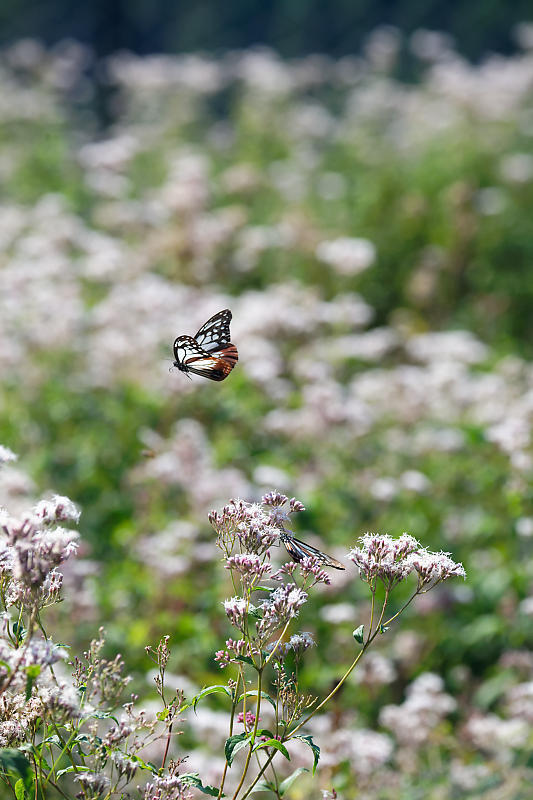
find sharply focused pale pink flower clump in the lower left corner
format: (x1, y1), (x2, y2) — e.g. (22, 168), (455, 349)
(0, 446), (207, 800)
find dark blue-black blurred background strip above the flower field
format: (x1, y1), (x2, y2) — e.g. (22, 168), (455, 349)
(0, 0), (533, 61)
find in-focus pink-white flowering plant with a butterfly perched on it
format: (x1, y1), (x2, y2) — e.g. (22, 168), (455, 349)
(202, 492), (465, 800)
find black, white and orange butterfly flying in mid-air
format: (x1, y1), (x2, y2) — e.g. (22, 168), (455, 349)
(174, 308), (239, 381)
